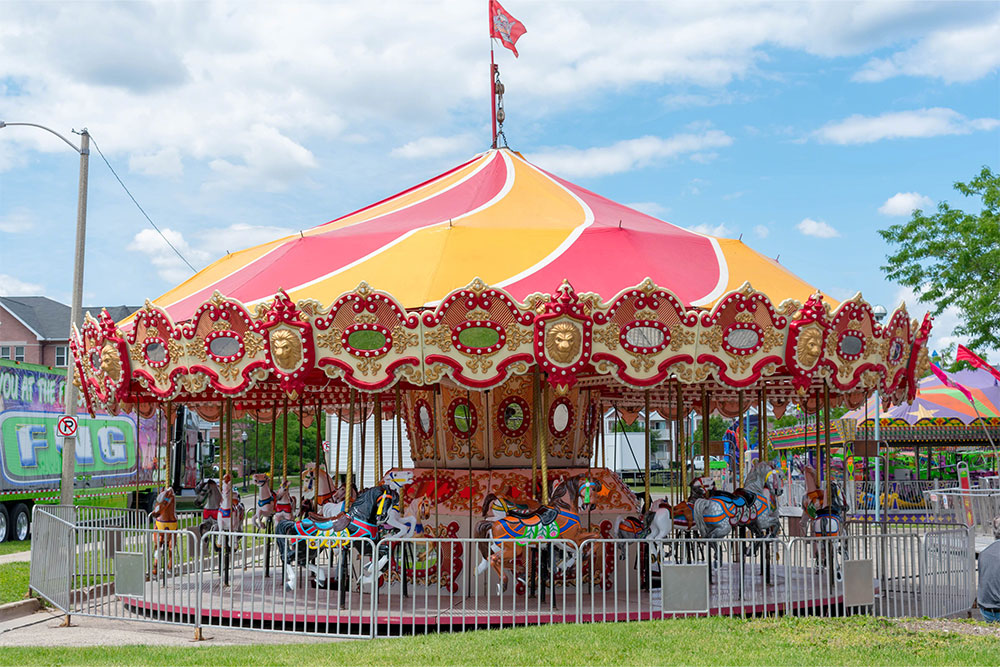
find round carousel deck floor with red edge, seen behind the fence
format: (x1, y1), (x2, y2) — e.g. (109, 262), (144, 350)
(118, 564), (872, 634)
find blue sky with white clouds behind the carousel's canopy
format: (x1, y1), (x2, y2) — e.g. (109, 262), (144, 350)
(0, 0), (1000, 354)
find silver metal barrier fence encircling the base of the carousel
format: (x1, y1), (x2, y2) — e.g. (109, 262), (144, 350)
(31, 507), (975, 638)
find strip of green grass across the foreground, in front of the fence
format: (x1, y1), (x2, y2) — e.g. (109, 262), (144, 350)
(0, 618), (1000, 667)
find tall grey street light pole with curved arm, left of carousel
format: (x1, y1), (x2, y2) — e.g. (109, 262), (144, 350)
(0, 120), (91, 505)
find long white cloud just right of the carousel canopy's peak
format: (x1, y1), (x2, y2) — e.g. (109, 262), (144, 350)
(529, 130), (733, 178)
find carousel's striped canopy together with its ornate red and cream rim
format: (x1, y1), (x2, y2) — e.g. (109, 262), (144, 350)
(71, 149), (931, 414)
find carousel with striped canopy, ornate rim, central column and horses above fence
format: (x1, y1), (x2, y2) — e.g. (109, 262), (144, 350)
(72, 148), (930, 632)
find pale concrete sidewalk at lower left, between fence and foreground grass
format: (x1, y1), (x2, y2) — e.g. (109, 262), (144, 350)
(0, 610), (340, 646)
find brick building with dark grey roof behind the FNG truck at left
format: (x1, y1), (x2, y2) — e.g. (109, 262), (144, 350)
(0, 296), (139, 368)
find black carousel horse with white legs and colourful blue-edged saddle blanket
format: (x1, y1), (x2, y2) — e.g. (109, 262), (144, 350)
(275, 478), (400, 590)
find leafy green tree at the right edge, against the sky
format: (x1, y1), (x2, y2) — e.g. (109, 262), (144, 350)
(879, 167), (1000, 349)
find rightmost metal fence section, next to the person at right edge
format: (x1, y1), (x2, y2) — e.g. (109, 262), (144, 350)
(921, 528), (976, 618)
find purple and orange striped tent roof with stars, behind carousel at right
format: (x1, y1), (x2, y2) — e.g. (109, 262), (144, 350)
(845, 370), (1000, 425)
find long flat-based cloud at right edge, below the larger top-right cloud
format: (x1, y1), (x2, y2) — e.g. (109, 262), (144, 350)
(814, 107), (1000, 144)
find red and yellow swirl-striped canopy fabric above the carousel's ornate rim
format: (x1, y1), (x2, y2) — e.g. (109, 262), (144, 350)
(146, 149), (817, 321)
